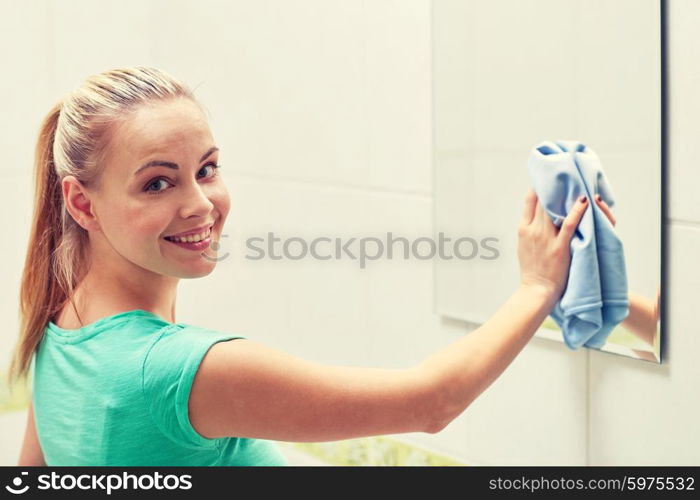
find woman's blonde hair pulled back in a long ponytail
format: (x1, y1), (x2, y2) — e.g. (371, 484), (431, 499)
(8, 66), (203, 386)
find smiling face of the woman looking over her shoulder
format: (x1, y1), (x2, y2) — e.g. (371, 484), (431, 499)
(77, 98), (230, 278)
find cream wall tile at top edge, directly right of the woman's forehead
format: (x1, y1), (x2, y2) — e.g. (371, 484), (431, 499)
(152, 0), (370, 186)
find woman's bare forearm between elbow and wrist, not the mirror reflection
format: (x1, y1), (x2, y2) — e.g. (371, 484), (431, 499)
(418, 286), (556, 425)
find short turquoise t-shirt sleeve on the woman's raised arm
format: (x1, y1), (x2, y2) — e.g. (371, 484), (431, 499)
(142, 325), (245, 448)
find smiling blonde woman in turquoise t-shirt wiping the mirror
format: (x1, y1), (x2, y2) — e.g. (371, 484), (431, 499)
(11, 67), (588, 466)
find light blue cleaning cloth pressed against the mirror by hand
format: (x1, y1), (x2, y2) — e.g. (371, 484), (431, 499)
(528, 141), (629, 349)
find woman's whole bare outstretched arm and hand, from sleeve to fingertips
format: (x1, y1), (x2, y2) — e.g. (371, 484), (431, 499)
(189, 192), (587, 441)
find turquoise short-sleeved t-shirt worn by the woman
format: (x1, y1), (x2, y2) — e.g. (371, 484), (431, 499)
(32, 309), (286, 466)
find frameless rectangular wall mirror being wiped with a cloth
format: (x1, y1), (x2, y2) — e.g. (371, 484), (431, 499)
(432, 0), (662, 363)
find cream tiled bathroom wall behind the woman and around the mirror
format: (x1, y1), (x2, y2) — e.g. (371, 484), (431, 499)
(0, 0), (700, 465)
